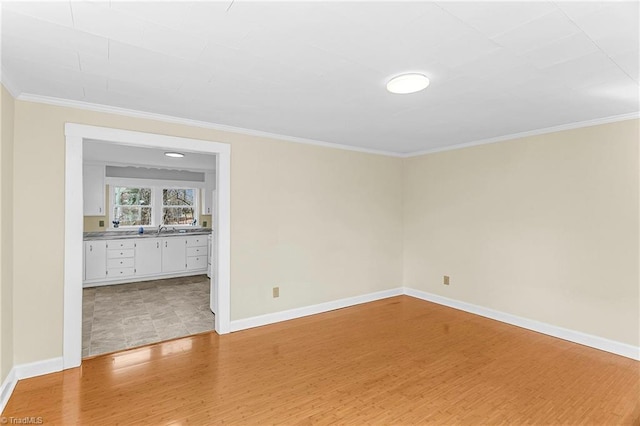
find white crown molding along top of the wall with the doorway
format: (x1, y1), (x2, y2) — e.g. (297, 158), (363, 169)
(17, 93), (401, 157)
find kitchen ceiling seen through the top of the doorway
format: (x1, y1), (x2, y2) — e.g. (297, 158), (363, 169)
(82, 140), (216, 172)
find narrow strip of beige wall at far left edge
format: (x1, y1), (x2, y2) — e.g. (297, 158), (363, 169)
(0, 86), (14, 382)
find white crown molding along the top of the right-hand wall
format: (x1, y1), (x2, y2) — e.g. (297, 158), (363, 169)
(400, 112), (640, 158)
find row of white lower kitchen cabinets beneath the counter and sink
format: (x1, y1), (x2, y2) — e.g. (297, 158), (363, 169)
(84, 235), (207, 284)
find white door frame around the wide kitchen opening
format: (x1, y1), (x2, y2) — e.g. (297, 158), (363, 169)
(62, 123), (231, 369)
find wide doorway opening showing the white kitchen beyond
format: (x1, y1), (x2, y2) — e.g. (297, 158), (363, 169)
(82, 139), (217, 358)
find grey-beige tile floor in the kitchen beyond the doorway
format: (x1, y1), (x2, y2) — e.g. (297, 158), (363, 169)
(82, 275), (214, 358)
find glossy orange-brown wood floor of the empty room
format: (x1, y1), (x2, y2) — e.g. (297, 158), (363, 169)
(3, 296), (640, 425)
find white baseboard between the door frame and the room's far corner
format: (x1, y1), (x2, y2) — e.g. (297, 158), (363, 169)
(231, 288), (404, 332)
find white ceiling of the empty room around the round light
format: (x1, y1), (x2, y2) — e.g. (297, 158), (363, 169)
(2, 0), (640, 153)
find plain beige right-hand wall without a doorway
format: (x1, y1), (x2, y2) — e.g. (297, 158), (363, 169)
(404, 120), (640, 346)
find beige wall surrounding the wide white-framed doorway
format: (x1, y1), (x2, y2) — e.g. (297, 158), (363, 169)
(14, 101), (402, 364)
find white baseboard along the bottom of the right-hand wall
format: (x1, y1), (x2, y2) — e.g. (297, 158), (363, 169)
(404, 287), (640, 361)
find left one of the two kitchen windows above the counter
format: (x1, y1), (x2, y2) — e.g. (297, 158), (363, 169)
(113, 186), (152, 226)
